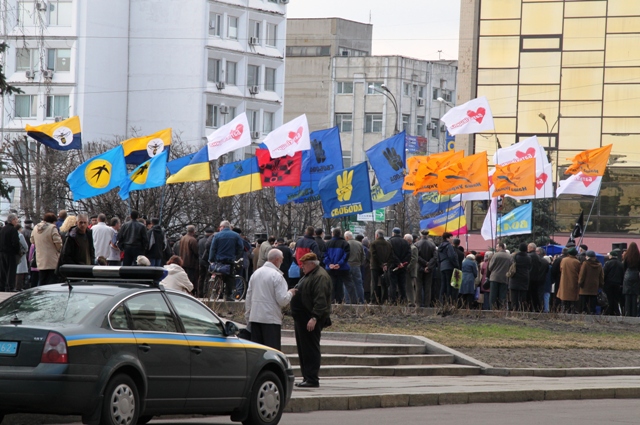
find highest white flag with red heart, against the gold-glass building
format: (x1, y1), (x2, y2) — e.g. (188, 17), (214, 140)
(440, 96), (494, 136)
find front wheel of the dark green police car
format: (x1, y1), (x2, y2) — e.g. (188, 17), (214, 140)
(242, 371), (285, 425)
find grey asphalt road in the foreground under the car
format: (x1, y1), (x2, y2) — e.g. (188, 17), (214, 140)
(36, 400), (640, 425)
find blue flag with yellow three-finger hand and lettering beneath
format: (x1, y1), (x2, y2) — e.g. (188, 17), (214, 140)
(318, 162), (373, 218)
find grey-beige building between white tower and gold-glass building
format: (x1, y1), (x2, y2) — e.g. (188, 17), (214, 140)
(284, 18), (457, 166)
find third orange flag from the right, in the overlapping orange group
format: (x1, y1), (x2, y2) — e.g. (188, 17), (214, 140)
(438, 152), (489, 195)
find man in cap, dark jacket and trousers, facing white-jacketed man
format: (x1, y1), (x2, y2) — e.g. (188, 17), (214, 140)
(291, 253), (331, 388)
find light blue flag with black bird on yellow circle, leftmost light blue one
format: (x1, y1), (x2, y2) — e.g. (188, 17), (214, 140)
(67, 146), (127, 201)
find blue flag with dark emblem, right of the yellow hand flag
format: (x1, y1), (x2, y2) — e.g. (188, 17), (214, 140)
(367, 131), (406, 193)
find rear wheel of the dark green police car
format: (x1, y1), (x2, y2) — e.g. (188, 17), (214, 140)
(100, 374), (140, 425)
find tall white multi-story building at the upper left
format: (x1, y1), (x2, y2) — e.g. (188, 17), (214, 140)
(0, 0), (288, 151)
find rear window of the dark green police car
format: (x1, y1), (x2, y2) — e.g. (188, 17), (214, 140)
(0, 290), (110, 325)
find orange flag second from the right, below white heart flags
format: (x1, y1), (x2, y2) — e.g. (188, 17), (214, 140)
(491, 158), (536, 198)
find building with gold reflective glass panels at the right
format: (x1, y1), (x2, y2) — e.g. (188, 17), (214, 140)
(456, 0), (640, 240)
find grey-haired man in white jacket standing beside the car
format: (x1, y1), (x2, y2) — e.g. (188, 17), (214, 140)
(244, 249), (296, 350)
